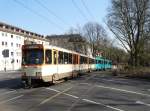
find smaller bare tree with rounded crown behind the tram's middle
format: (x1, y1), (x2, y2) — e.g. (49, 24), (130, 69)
(83, 22), (108, 55)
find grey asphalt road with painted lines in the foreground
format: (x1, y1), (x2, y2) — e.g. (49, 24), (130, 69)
(0, 72), (150, 111)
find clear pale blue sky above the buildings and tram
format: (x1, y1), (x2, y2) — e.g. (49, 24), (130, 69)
(0, 0), (110, 35)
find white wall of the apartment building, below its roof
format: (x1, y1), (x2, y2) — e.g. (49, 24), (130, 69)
(0, 31), (49, 71)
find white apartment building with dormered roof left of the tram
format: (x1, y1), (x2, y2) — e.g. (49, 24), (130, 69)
(0, 22), (49, 71)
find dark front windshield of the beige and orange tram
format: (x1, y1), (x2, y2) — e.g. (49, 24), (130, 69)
(22, 49), (44, 65)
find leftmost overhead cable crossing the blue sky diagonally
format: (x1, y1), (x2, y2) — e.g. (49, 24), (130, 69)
(14, 0), (63, 30)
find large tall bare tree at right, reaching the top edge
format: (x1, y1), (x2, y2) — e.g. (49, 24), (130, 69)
(107, 0), (150, 66)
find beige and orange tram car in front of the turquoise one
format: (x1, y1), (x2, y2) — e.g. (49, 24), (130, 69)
(22, 44), (95, 85)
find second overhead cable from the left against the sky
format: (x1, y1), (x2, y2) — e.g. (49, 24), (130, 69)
(34, 0), (68, 25)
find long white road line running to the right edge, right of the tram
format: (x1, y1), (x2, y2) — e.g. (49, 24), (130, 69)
(96, 85), (150, 97)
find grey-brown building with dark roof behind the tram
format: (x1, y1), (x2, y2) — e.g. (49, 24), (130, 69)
(46, 34), (92, 57)
